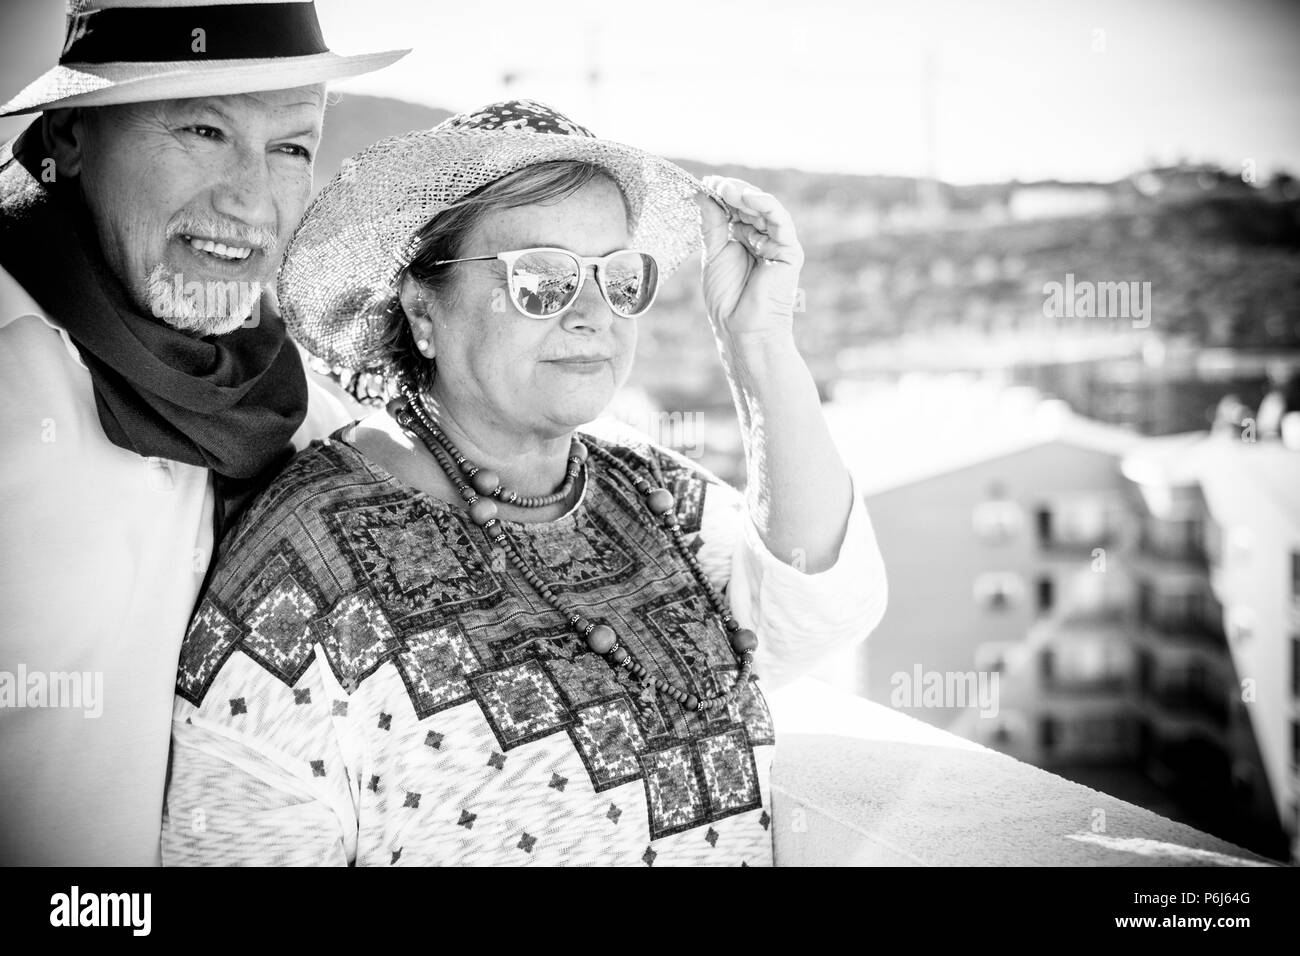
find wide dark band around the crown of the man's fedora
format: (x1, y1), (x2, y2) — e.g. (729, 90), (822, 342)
(59, 3), (329, 64)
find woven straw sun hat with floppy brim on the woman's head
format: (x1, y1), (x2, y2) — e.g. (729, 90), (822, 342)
(278, 100), (709, 369)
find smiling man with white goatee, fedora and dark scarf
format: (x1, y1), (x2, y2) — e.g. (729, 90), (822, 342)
(0, 0), (407, 865)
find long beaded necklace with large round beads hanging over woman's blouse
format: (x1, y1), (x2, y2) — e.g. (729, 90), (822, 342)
(387, 385), (758, 710)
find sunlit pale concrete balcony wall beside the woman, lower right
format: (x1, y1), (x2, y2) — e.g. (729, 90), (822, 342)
(768, 679), (1273, 866)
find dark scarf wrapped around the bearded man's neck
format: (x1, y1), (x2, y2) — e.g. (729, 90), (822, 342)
(0, 120), (307, 535)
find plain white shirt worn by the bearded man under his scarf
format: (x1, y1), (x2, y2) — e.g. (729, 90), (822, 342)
(0, 269), (351, 866)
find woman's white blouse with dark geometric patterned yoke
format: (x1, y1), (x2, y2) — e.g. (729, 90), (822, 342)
(163, 427), (885, 865)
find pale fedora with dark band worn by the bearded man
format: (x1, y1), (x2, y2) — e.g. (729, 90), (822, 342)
(0, 0), (411, 116)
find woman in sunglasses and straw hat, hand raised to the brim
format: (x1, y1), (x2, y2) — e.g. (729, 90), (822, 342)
(164, 101), (885, 865)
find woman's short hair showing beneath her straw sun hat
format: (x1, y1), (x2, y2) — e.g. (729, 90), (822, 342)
(374, 160), (632, 392)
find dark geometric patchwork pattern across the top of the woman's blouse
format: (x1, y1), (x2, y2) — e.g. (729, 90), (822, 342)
(177, 433), (775, 842)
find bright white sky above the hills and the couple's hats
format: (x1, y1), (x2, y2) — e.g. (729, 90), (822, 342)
(0, 0), (1300, 182)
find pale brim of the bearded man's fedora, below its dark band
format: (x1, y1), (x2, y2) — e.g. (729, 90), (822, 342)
(0, 49), (411, 116)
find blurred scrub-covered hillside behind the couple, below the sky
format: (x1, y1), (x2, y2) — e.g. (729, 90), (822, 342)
(306, 95), (1300, 437)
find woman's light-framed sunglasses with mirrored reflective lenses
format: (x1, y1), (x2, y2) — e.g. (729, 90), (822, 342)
(434, 246), (659, 319)
